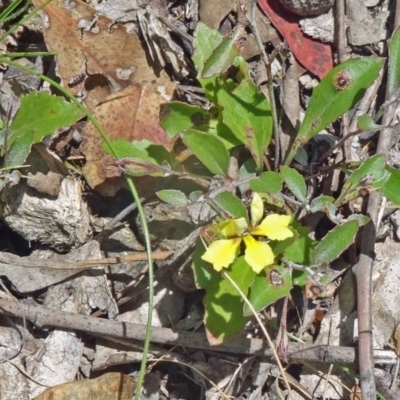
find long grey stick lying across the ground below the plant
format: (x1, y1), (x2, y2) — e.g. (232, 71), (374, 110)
(0, 299), (397, 366)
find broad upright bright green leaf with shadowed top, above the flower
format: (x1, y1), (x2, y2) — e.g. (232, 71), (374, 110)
(218, 79), (272, 170)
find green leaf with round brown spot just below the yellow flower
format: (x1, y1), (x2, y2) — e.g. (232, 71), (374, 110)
(244, 265), (293, 316)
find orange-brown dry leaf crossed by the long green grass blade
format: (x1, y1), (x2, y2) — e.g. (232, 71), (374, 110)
(80, 79), (173, 196)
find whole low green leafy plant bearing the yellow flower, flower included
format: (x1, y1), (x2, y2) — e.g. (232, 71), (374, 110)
(102, 23), (400, 343)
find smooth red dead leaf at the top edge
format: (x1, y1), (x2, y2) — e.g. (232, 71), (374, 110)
(258, 0), (333, 78)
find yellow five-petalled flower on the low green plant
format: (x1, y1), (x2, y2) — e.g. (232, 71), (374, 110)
(201, 193), (293, 274)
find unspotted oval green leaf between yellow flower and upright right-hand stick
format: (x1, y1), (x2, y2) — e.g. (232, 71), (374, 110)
(313, 221), (358, 264)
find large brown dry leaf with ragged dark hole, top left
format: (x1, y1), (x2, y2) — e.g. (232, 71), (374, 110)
(33, 0), (161, 109)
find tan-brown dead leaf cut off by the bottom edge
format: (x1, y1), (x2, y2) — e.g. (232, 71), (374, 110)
(36, 372), (136, 400)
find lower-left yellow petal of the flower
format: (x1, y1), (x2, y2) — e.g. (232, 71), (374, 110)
(201, 238), (242, 271)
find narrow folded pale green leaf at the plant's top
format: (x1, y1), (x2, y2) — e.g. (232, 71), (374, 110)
(200, 24), (245, 78)
